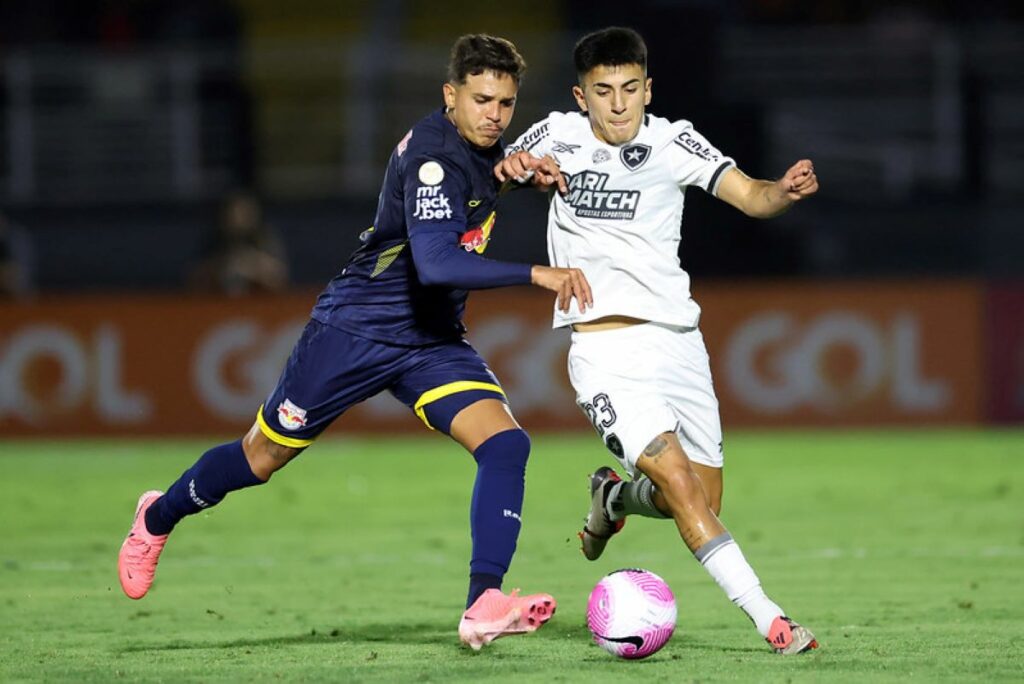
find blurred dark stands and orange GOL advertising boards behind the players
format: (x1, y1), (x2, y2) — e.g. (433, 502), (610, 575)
(0, 0), (1024, 437)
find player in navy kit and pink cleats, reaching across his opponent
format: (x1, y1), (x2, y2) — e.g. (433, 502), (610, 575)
(118, 35), (592, 649)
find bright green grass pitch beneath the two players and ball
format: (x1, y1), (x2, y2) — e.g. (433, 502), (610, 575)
(0, 430), (1024, 683)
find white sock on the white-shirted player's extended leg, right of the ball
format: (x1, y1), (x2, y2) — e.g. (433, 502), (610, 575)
(693, 532), (785, 637)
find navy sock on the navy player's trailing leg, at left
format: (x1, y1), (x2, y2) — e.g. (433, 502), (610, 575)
(145, 439), (263, 535)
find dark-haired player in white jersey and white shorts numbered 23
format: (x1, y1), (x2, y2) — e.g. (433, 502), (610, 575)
(495, 28), (818, 654)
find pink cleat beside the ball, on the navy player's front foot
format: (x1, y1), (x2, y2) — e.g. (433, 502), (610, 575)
(459, 589), (557, 651)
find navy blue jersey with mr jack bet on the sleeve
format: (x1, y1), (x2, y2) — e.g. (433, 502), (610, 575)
(312, 110), (529, 346)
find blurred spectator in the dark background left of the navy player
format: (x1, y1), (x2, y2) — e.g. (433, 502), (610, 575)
(189, 193), (288, 295)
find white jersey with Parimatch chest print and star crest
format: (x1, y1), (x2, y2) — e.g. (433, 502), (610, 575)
(508, 112), (735, 328)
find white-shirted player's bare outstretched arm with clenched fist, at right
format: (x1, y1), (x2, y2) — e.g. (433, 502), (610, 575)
(718, 159), (818, 218)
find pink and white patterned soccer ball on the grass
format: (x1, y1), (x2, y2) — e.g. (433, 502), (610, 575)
(587, 568), (676, 659)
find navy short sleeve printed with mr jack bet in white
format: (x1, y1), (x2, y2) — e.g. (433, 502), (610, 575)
(402, 154), (467, 236)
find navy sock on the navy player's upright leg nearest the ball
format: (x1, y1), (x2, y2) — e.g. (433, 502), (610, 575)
(467, 429), (529, 607)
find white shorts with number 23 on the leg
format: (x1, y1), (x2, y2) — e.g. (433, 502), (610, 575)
(568, 323), (723, 477)
